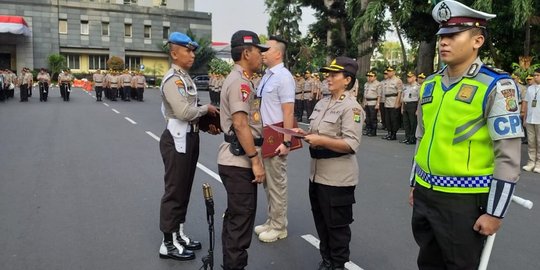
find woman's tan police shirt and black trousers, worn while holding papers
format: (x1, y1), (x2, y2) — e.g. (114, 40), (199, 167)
(309, 91), (365, 269)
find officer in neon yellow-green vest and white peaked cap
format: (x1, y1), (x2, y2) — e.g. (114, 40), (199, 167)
(409, 0), (523, 270)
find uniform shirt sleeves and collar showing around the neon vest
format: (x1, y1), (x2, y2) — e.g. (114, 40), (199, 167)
(410, 58), (522, 185)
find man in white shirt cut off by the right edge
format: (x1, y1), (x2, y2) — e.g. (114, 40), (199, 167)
(521, 68), (540, 173)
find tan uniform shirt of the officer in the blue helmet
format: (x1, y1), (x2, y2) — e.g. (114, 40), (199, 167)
(161, 64), (208, 122)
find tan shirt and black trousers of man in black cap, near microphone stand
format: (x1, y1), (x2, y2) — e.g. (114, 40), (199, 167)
(218, 65), (262, 269)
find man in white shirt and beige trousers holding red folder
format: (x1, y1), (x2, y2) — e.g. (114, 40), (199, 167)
(255, 36), (295, 242)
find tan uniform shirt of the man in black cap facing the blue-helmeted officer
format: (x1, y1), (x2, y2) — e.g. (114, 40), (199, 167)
(218, 64), (262, 168)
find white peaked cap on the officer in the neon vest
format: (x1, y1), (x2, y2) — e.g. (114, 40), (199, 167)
(431, 0), (496, 35)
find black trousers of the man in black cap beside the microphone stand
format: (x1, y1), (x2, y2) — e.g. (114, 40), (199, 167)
(218, 165), (257, 270)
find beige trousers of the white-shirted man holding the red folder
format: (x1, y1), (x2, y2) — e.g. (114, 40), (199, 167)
(263, 156), (287, 230)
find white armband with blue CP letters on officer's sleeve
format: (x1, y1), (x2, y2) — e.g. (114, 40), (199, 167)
(488, 114), (523, 140)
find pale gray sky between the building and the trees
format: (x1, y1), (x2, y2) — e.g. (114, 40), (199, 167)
(195, 0), (315, 43)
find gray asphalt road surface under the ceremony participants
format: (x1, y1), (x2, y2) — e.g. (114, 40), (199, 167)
(0, 85), (540, 270)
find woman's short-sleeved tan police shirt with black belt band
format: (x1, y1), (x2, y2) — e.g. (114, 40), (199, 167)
(309, 91), (365, 186)
